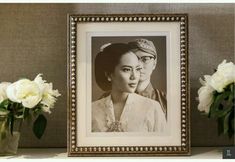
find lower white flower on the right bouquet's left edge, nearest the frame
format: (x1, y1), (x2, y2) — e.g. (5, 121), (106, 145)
(198, 75), (215, 114)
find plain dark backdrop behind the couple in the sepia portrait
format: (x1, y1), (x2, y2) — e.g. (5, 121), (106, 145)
(91, 35), (166, 101)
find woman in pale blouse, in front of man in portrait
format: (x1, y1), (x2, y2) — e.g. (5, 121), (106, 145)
(92, 43), (166, 132)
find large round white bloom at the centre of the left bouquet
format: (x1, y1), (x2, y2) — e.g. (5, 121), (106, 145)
(7, 79), (42, 108)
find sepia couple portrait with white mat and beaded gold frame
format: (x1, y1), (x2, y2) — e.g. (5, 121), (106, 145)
(67, 14), (190, 156)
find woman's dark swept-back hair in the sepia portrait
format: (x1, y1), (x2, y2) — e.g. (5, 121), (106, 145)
(95, 43), (131, 91)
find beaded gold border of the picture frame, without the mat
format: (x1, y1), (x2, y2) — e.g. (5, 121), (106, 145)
(67, 14), (191, 156)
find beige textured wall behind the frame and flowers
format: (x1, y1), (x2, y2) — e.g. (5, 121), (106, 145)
(0, 4), (234, 147)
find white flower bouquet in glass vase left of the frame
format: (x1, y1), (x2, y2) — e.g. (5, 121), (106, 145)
(0, 74), (60, 155)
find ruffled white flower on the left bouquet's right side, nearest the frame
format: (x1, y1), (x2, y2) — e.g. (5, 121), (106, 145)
(34, 74), (61, 113)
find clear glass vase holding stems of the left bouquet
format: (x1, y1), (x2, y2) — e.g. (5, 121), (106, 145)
(0, 116), (22, 156)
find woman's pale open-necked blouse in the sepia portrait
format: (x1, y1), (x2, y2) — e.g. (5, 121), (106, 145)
(92, 93), (166, 132)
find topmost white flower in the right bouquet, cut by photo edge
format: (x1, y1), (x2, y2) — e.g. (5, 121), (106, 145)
(210, 60), (235, 92)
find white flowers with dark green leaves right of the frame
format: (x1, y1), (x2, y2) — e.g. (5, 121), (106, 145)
(198, 60), (235, 138)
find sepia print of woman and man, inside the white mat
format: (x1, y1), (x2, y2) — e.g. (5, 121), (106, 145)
(91, 35), (167, 133)
